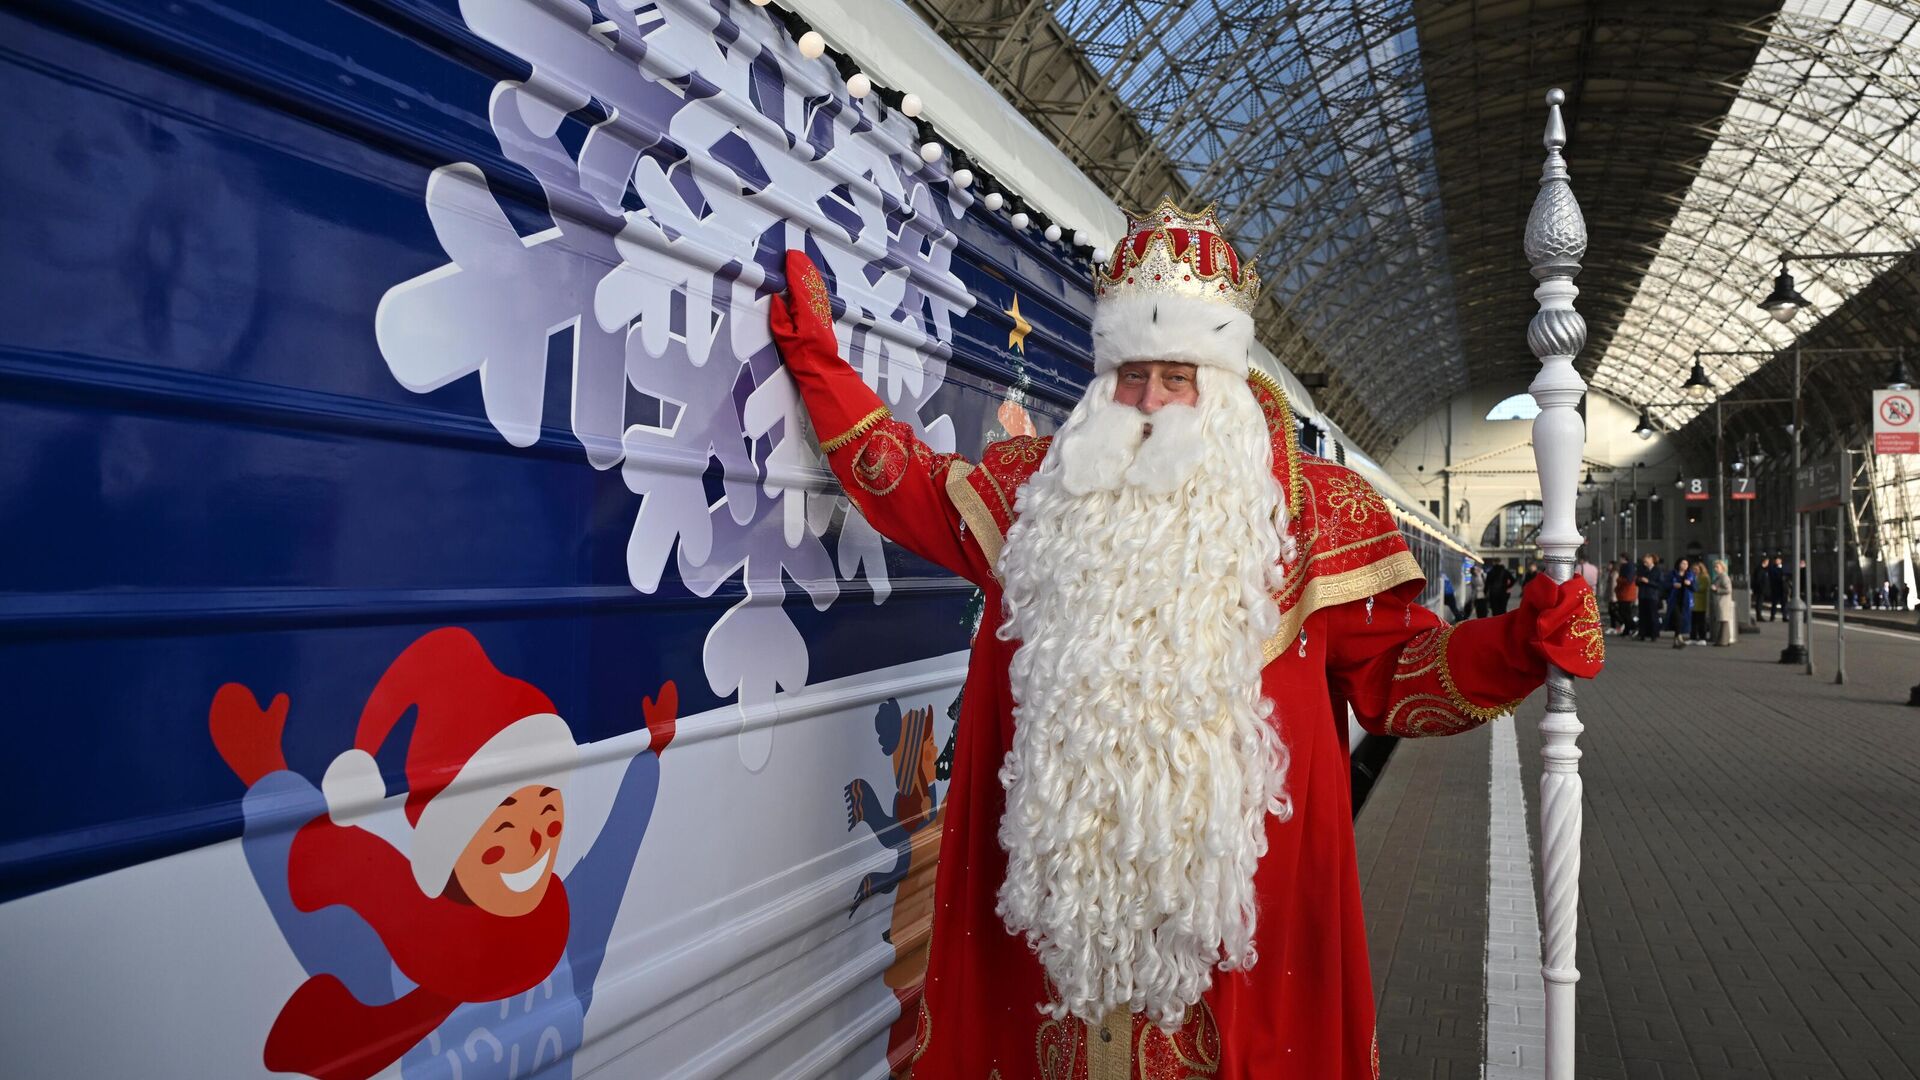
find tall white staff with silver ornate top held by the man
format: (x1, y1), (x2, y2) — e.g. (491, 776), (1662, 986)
(1526, 88), (1586, 1080)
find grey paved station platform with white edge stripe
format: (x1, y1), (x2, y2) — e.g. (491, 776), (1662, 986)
(1356, 619), (1920, 1080)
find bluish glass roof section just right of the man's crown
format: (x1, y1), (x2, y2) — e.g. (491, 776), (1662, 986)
(1054, 0), (1467, 429)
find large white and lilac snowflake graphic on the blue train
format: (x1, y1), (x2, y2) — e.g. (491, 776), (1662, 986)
(376, 0), (973, 769)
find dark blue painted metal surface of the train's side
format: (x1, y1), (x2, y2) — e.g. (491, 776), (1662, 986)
(0, 0), (1087, 897)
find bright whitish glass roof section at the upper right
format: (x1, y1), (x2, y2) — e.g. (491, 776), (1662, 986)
(1594, 0), (1920, 427)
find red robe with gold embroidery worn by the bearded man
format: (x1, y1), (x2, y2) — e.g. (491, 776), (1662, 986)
(772, 255), (1599, 1080)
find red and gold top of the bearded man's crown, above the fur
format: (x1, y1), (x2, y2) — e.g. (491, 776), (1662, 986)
(1092, 198), (1260, 315)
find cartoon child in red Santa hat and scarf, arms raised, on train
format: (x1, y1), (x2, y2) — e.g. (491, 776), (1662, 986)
(209, 626), (678, 1080)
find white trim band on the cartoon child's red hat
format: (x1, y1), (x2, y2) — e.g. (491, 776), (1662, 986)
(411, 713), (580, 896)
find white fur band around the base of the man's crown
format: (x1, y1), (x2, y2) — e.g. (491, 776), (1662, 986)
(1092, 294), (1254, 375)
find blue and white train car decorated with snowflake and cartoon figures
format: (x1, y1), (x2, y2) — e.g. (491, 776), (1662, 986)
(0, 0), (1466, 1078)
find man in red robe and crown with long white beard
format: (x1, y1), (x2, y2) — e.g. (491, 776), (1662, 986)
(772, 204), (1601, 1080)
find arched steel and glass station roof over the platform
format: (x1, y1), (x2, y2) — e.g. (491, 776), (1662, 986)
(910, 0), (1920, 454)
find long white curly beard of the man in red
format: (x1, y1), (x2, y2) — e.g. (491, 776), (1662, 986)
(996, 367), (1292, 1028)
